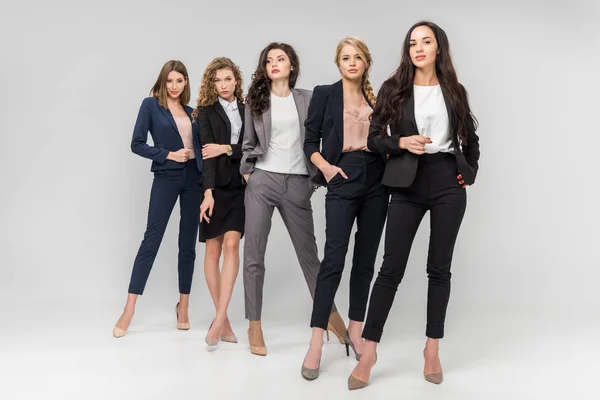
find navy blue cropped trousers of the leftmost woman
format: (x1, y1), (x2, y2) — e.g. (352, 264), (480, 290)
(129, 160), (200, 294)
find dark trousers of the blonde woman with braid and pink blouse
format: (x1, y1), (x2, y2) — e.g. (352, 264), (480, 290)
(310, 151), (389, 329)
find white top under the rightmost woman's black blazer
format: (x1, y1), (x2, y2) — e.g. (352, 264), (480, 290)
(414, 85), (454, 154)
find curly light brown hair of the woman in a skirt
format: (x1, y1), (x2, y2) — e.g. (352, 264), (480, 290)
(192, 57), (244, 118)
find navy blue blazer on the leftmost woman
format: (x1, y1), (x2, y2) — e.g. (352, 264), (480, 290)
(131, 97), (202, 172)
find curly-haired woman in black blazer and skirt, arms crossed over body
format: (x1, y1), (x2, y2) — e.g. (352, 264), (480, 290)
(194, 57), (245, 346)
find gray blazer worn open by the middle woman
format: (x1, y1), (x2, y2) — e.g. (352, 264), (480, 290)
(240, 89), (318, 178)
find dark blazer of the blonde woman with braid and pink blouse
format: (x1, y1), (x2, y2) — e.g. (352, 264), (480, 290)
(304, 80), (380, 186)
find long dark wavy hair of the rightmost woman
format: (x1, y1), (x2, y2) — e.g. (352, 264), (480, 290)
(372, 21), (477, 144)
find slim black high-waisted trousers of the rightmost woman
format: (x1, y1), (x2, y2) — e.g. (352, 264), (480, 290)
(363, 153), (467, 342)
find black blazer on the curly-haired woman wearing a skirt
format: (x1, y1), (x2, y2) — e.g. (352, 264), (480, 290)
(198, 101), (244, 189)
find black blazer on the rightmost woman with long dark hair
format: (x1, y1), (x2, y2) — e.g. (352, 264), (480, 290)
(367, 84), (479, 187)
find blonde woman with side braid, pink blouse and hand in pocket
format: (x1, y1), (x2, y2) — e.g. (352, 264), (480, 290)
(301, 37), (388, 380)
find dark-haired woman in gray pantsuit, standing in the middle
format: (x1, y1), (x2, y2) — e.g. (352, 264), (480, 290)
(240, 43), (346, 356)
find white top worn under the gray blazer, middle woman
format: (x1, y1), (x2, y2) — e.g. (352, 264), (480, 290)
(255, 93), (308, 175)
